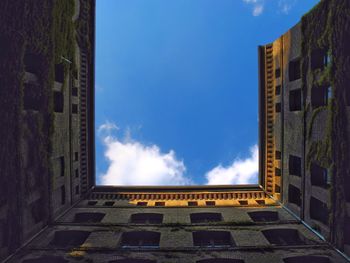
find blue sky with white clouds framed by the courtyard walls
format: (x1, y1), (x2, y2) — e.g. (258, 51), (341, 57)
(95, 0), (318, 185)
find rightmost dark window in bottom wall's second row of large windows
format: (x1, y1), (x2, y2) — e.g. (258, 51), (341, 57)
(262, 228), (306, 246)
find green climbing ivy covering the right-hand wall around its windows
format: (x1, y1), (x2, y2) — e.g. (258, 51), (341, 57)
(302, 0), (350, 250)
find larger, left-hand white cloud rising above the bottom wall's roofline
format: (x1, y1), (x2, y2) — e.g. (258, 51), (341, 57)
(98, 123), (192, 185)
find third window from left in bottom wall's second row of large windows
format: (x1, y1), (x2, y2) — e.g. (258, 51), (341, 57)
(192, 231), (235, 247)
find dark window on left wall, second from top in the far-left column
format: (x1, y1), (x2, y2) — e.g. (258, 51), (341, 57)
(23, 83), (43, 111)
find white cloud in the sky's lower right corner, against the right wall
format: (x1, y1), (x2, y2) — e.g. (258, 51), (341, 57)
(205, 145), (259, 185)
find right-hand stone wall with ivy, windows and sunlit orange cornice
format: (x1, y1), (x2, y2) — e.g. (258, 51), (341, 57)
(259, 0), (350, 260)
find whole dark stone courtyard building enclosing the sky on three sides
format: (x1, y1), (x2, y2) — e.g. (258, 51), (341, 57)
(0, 0), (350, 263)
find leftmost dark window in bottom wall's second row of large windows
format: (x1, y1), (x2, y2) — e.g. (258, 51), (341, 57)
(51, 230), (90, 247)
